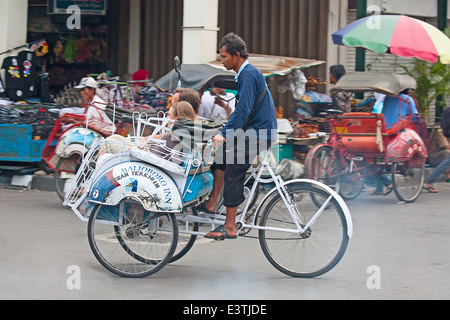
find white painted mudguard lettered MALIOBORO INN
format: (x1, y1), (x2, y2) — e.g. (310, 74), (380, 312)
(89, 162), (183, 213)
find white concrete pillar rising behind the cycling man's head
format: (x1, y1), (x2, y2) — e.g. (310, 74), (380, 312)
(182, 0), (219, 64)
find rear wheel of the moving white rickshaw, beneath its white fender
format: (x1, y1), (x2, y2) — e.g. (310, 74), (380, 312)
(259, 184), (349, 278)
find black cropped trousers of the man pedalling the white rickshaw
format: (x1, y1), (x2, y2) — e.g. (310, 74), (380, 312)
(211, 137), (272, 207)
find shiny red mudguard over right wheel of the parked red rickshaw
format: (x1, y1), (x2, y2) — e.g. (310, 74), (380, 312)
(385, 128), (428, 162)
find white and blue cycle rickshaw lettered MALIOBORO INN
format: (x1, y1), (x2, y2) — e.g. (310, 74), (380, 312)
(64, 58), (353, 278)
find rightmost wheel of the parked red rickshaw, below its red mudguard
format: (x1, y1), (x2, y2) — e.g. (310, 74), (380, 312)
(392, 154), (425, 203)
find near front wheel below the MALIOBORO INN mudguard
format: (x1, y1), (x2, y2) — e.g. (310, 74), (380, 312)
(88, 199), (178, 278)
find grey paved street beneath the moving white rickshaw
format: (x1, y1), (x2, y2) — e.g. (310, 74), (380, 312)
(0, 183), (450, 300)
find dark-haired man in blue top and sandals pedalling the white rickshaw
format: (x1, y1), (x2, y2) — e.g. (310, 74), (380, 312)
(200, 33), (277, 240)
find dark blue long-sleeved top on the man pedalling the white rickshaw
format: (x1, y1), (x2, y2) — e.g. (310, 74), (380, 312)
(220, 64), (277, 140)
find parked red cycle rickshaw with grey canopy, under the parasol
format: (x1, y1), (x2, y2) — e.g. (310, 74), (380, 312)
(305, 72), (429, 203)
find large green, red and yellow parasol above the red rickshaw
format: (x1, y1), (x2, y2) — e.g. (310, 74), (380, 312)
(332, 15), (450, 64)
